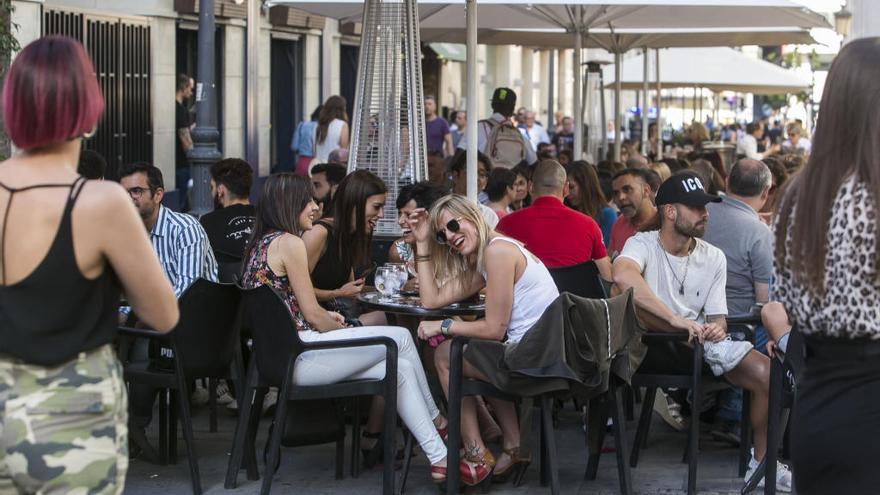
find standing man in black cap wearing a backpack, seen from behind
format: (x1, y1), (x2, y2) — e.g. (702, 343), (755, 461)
(458, 88), (538, 168)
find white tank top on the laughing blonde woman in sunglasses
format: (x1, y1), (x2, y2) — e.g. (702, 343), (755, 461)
(483, 237), (559, 343)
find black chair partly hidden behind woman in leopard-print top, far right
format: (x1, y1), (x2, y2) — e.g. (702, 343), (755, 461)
(741, 328), (804, 495)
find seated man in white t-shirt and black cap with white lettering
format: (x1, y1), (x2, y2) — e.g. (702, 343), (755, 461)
(612, 172), (791, 491)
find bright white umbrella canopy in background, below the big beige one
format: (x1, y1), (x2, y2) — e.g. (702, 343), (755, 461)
(604, 47), (810, 94)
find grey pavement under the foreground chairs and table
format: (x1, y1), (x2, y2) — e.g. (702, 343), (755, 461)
(125, 402), (784, 495)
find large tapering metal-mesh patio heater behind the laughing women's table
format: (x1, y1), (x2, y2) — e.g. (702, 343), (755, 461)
(348, 0), (427, 235)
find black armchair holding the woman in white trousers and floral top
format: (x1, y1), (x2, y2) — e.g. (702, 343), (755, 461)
(225, 285), (397, 495)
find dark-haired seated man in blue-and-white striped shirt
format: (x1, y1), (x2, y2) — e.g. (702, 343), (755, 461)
(119, 163), (217, 461)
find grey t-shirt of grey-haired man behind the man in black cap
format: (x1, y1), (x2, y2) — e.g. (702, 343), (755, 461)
(703, 196), (773, 315)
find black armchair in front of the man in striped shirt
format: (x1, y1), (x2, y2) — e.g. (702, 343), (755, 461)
(119, 279), (244, 494)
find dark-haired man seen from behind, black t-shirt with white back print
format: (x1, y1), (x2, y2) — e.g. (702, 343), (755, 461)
(199, 158), (254, 282)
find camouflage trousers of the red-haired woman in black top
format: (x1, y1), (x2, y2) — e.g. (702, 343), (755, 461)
(0, 345), (128, 495)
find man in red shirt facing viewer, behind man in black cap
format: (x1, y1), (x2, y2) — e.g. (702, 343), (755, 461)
(608, 168), (657, 258)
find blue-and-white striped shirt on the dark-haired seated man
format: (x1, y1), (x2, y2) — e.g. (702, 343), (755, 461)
(150, 206), (217, 298)
